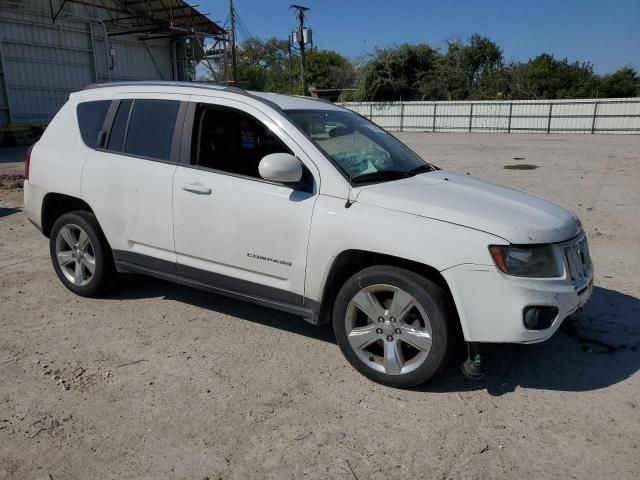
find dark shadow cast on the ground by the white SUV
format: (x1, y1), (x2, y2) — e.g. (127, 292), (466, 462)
(109, 275), (640, 396)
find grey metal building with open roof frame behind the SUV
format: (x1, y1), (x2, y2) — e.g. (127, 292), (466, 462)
(0, 0), (227, 137)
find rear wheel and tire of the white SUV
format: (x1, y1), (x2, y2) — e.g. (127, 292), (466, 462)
(49, 210), (114, 297)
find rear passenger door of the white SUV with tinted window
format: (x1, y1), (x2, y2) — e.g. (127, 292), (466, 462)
(82, 94), (188, 273)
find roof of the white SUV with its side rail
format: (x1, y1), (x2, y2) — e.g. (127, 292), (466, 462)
(84, 81), (345, 111)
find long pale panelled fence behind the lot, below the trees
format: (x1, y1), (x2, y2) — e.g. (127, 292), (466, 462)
(342, 97), (640, 134)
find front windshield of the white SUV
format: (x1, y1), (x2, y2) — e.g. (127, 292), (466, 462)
(285, 110), (434, 183)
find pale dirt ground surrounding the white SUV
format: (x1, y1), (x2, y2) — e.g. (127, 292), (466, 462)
(0, 134), (640, 480)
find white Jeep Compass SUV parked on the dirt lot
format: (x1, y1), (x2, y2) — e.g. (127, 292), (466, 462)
(24, 82), (593, 387)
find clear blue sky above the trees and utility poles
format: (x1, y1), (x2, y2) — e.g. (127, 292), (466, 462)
(198, 0), (640, 73)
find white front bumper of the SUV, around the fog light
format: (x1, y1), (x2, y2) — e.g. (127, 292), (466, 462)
(442, 244), (593, 343)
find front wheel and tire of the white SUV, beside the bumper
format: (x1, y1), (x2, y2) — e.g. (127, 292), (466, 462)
(332, 266), (454, 388)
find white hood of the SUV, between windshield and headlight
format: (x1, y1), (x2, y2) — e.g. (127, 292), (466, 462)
(356, 170), (581, 244)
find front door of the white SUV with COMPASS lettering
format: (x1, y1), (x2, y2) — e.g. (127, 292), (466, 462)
(173, 97), (318, 305)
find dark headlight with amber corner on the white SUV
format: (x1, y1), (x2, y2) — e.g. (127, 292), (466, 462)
(489, 245), (561, 277)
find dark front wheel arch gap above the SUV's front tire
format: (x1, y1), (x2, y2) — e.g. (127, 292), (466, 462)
(318, 250), (461, 329)
